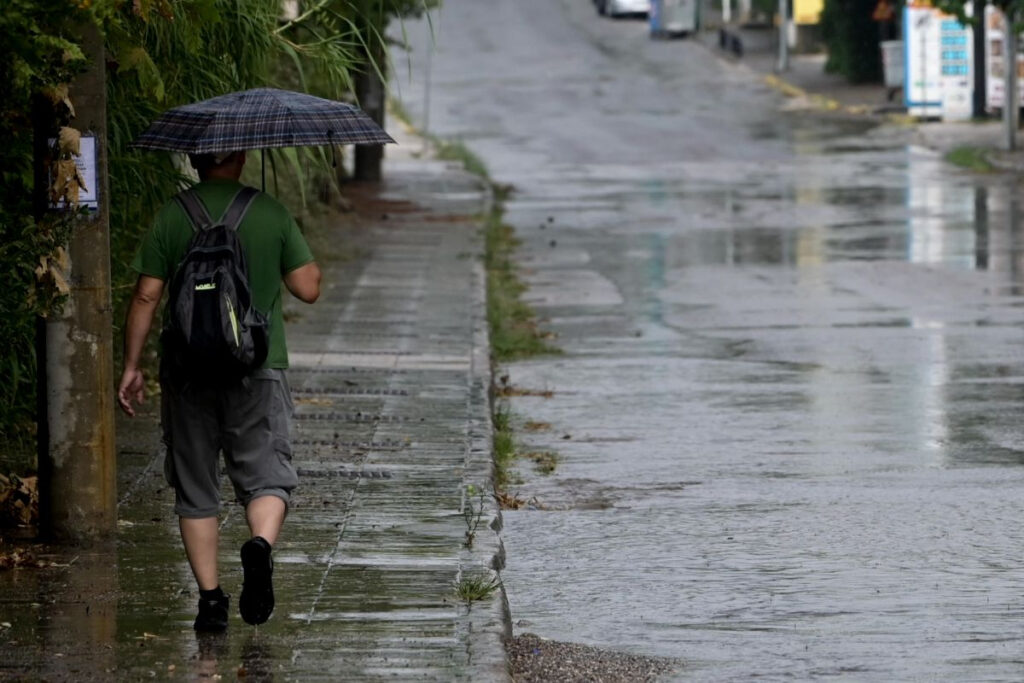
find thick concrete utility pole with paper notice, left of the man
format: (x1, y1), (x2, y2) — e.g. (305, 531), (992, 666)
(39, 23), (117, 542)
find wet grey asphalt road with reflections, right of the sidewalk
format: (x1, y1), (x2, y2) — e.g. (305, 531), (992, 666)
(395, 0), (1024, 680)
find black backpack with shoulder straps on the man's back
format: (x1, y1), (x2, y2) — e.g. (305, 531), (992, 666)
(162, 187), (267, 385)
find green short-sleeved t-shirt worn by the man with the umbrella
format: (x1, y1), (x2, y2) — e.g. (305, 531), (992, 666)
(132, 179), (313, 368)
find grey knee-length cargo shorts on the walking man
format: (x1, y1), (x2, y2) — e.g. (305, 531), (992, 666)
(160, 370), (298, 518)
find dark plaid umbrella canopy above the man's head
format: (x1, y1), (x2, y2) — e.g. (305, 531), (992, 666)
(132, 88), (394, 154)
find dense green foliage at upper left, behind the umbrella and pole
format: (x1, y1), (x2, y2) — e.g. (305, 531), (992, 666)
(0, 0), (439, 479)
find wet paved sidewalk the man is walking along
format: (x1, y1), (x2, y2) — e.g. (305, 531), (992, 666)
(0, 126), (509, 681)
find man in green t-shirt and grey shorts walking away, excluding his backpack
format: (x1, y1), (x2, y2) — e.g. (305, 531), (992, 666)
(118, 152), (321, 632)
